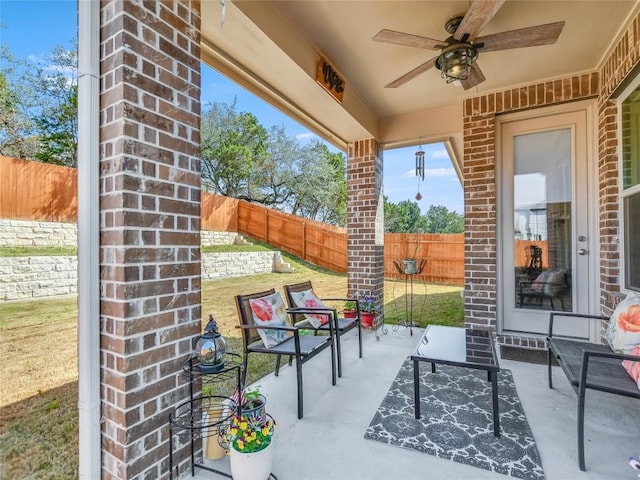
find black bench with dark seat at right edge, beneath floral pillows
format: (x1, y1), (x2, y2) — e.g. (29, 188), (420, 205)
(547, 312), (640, 471)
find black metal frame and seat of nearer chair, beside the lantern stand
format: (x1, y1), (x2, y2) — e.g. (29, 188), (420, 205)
(235, 289), (336, 419)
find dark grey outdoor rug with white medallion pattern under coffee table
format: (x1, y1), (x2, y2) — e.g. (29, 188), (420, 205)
(364, 358), (544, 480)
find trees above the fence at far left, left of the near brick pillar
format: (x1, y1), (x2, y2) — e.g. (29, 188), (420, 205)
(0, 44), (78, 167)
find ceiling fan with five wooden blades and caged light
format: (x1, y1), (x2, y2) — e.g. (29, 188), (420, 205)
(373, 0), (564, 90)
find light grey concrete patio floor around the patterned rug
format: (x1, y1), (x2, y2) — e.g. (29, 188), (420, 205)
(195, 327), (640, 480)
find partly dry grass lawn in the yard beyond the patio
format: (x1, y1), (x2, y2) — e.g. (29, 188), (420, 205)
(0, 251), (463, 480)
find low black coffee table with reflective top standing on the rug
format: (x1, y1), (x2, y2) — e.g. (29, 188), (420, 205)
(411, 325), (500, 437)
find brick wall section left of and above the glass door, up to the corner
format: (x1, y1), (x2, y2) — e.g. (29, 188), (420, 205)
(463, 73), (598, 348)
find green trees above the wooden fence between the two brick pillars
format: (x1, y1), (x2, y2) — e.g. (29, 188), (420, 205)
(202, 100), (347, 225)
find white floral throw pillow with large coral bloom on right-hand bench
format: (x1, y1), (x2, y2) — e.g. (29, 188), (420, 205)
(605, 294), (640, 353)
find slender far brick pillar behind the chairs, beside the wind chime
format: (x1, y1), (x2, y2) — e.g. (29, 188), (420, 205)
(347, 139), (384, 314)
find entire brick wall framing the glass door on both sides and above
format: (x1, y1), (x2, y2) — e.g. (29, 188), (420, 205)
(463, 8), (640, 348)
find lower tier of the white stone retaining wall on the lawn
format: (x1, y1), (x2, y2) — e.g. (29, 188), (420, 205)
(0, 251), (288, 301)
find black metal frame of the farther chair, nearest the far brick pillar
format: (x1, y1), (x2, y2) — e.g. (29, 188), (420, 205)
(283, 281), (362, 377)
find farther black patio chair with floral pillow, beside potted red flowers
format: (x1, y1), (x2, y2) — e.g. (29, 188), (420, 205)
(284, 281), (362, 377)
